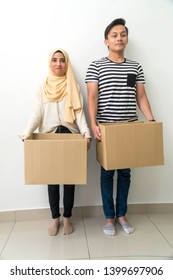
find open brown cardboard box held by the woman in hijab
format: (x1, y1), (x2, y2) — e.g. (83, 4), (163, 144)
(24, 133), (87, 184)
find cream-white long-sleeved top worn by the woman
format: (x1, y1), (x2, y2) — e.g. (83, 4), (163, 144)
(20, 83), (91, 139)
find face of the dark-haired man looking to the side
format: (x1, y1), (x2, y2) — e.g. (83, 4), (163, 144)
(105, 25), (128, 52)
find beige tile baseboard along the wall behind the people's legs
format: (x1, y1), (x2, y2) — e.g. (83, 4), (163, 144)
(0, 203), (173, 222)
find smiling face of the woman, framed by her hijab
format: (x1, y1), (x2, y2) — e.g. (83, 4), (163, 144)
(50, 52), (67, 77)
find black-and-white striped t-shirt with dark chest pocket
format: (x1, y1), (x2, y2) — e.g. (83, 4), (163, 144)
(85, 57), (145, 123)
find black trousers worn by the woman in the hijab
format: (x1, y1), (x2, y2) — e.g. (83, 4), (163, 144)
(48, 126), (75, 219)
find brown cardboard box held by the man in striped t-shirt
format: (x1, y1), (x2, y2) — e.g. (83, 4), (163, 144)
(96, 122), (164, 170)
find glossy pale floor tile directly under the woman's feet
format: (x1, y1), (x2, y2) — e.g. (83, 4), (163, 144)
(1, 218), (89, 260)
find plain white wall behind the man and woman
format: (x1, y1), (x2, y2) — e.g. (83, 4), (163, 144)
(0, 0), (173, 211)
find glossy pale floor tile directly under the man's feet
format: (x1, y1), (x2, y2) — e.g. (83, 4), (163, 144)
(84, 215), (173, 259)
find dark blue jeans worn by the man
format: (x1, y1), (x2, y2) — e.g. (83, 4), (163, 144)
(100, 166), (131, 219)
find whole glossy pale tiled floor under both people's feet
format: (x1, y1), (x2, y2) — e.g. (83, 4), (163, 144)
(0, 211), (173, 260)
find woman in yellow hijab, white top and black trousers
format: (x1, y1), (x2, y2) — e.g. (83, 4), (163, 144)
(20, 48), (91, 236)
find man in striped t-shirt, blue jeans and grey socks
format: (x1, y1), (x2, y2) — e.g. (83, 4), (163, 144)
(85, 18), (154, 235)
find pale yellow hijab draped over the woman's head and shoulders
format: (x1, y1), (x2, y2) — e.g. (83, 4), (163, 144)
(43, 48), (81, 123)
